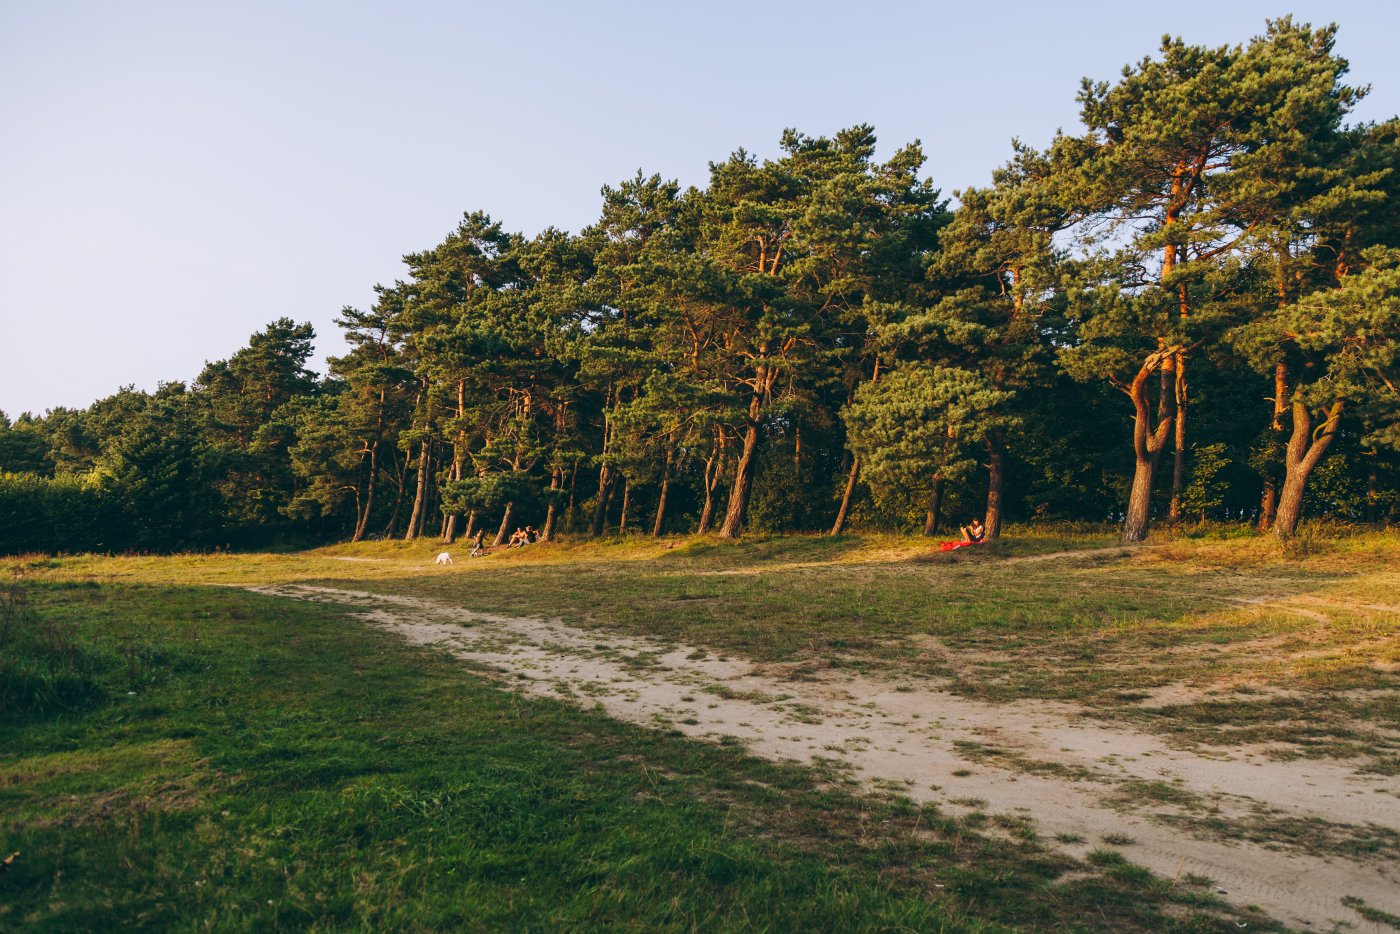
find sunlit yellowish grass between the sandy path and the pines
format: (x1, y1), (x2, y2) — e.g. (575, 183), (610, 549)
(212, 529), (1400, 774)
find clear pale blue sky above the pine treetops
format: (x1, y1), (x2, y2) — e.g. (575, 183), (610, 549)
(0, 0), (1400, 414)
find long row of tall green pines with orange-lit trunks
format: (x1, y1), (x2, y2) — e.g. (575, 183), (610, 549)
(0, 20), (1400, 550)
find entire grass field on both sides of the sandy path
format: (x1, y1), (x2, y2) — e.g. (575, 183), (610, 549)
(0, 531), (1400, 931)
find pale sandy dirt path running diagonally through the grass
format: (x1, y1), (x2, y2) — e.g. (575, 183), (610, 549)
(253, 584), (1400, 931)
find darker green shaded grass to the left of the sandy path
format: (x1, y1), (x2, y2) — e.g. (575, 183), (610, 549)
(0, 571), (1259, 931)
